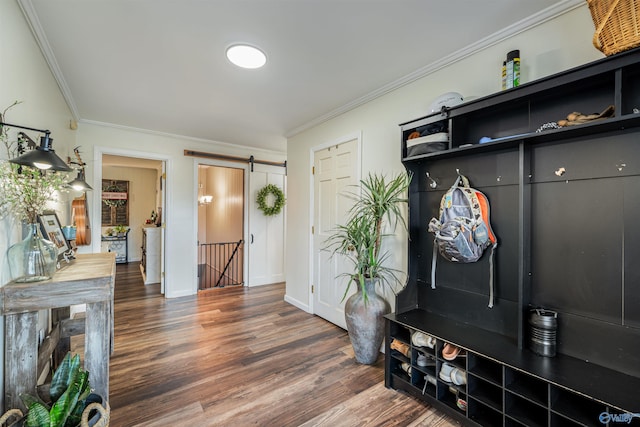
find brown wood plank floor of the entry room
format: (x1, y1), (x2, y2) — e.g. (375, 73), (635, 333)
(86, 263), (458, 427)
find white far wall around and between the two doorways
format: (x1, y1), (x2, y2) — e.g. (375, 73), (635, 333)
(77, 121), (286, 298)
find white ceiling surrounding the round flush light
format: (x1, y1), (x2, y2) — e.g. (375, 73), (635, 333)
(18, 0), (583, 151)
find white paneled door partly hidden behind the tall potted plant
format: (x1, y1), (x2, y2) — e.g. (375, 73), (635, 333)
(313, 138), (360, 329)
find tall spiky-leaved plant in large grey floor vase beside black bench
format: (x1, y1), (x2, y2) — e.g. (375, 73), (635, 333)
(327, 173), (411, 364)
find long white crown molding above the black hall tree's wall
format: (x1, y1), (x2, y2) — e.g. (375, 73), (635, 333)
(284, 0), (586, 138)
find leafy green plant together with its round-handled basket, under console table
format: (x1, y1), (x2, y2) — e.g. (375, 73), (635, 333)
(0, 353), (109, 427)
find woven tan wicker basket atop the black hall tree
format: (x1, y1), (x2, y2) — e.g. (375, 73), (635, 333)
(587, 0), (640, 56)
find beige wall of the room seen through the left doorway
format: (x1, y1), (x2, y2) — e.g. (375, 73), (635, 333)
(102, 166), (158, 261)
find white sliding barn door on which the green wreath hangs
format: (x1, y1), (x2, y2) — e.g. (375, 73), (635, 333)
(245, 164), (287, 286)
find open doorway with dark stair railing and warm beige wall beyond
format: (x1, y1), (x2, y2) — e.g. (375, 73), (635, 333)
(198, 164), (245, 291)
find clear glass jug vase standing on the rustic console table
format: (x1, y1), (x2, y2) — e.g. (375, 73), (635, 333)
(7, 224), (58, 283)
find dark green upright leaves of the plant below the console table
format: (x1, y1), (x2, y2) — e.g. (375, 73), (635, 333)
(20, 353), (91, 427)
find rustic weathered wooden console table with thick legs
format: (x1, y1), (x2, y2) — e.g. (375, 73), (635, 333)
(0, 253), (115, 410)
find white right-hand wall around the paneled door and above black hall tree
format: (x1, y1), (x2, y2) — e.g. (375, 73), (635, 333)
(286, 2), (603, 314)
